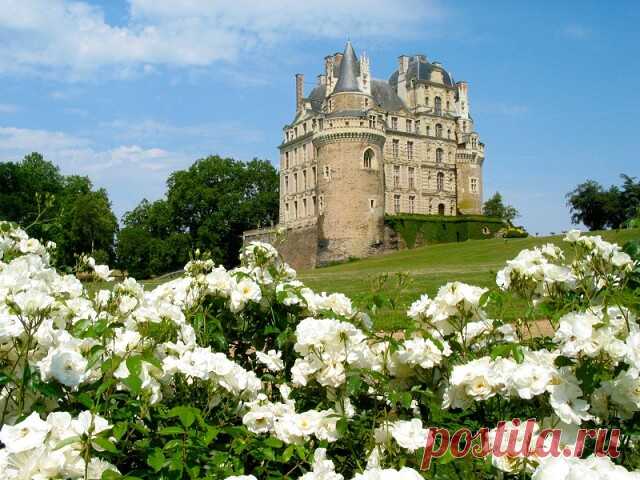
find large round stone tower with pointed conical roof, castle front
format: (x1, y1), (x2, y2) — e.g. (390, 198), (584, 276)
(313, 43), (385, 264)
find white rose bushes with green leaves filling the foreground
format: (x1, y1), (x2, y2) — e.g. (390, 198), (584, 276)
(0, 218), (640, 480)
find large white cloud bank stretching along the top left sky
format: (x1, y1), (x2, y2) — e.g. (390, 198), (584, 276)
(0, 0), (443, 78)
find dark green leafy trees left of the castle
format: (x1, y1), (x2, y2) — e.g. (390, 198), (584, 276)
(0, 153), (279, 278)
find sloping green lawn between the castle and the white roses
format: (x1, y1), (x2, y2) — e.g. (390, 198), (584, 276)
(299, 229), (640, 329)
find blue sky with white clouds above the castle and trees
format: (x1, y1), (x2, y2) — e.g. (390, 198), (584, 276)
(0, 0), (640, 233)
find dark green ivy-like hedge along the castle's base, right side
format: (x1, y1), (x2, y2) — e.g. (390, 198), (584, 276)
(385, 214), (505, 248)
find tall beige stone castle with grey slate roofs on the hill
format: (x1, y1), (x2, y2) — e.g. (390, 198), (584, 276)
(245, 42), (484, 268)
